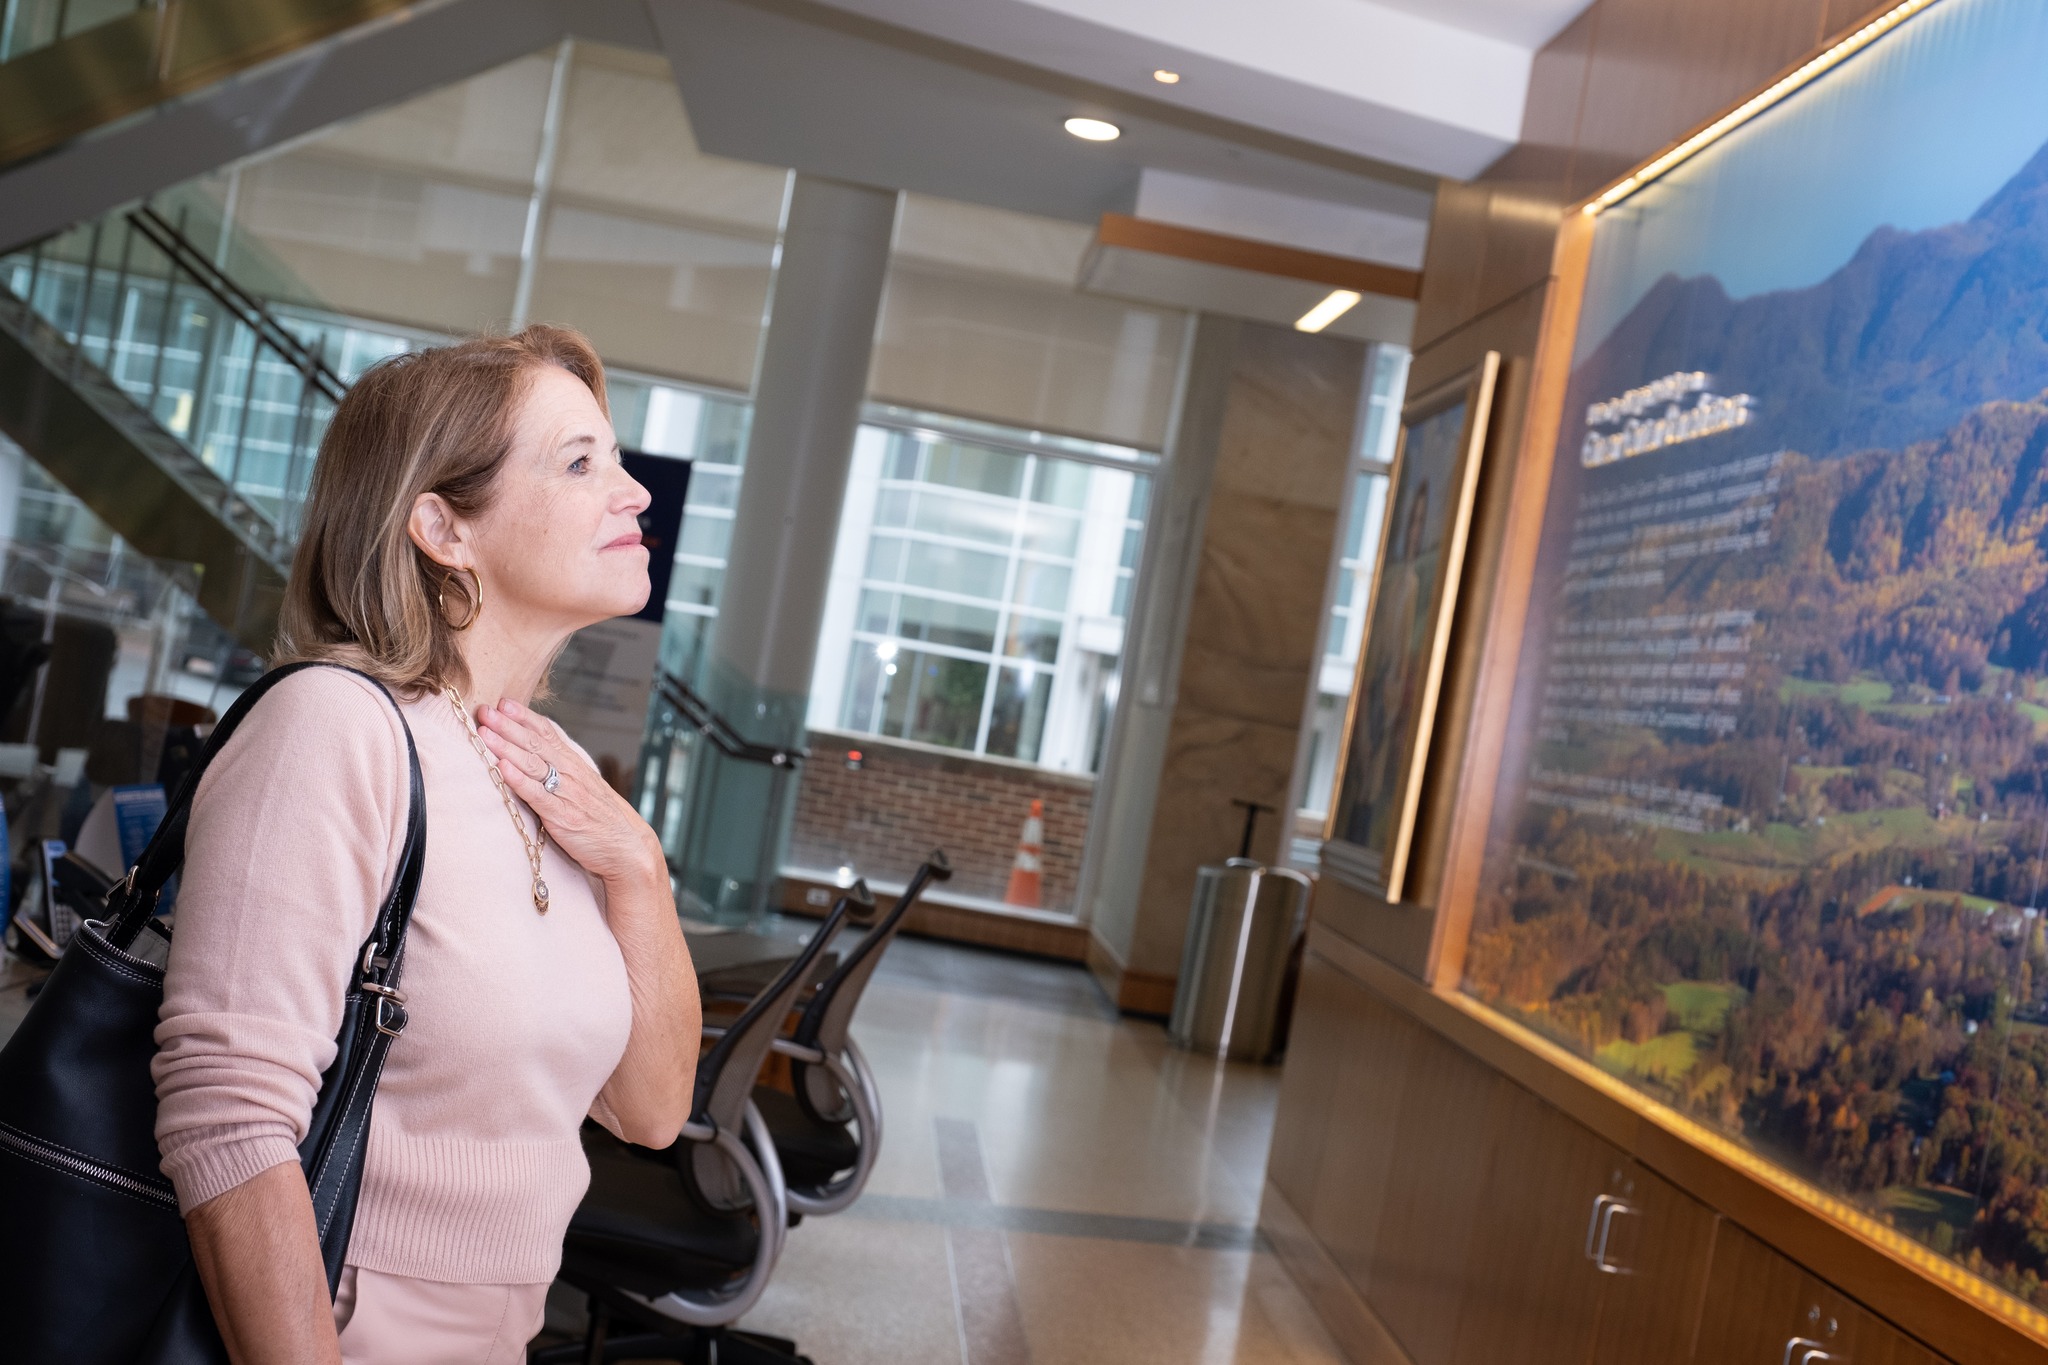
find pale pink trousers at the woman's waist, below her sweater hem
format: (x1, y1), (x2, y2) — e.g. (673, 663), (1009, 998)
(334, 1265), (547, 1365)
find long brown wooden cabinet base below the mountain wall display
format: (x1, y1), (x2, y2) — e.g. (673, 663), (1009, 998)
(1270, 952), (1944, 1365)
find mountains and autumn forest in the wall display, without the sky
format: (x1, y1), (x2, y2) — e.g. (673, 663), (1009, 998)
(1466, 130), (2048, 1308)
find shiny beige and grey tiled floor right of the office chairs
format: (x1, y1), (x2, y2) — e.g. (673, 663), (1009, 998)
(551, 939), (1341, 1365)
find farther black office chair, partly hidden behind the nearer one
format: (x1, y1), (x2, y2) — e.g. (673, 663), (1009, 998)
(754, 849), (952, 1222)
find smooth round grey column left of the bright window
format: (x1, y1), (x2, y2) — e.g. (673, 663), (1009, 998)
(680, 176), (897, 917)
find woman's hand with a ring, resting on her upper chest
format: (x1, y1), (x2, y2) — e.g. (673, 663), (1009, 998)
(477, 702), (668, 892)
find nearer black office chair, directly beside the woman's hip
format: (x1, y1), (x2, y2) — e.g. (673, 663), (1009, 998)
(530, 882), (874, 1365)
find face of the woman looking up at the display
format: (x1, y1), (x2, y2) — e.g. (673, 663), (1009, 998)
(469, 364), (649, 630)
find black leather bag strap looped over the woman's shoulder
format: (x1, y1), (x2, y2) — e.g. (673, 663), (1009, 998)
(106, 661), (426, 990)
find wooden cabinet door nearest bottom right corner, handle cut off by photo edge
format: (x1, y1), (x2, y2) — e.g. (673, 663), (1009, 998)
(1692, 1222), (1944, 1365)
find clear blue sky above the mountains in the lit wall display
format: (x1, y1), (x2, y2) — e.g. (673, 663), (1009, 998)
(1577, 0), (2048, 358)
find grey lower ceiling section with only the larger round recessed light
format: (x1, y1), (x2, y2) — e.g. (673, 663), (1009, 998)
(647, 0), (1434, 225)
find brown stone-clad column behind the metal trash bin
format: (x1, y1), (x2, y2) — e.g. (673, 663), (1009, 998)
(1081, 315), (1366, 1015)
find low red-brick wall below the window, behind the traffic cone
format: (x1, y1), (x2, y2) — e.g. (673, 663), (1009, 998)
(788, 731), (1096, 911)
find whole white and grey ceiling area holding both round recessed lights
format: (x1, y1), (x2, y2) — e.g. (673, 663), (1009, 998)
(647, 0), (1587, 268)
